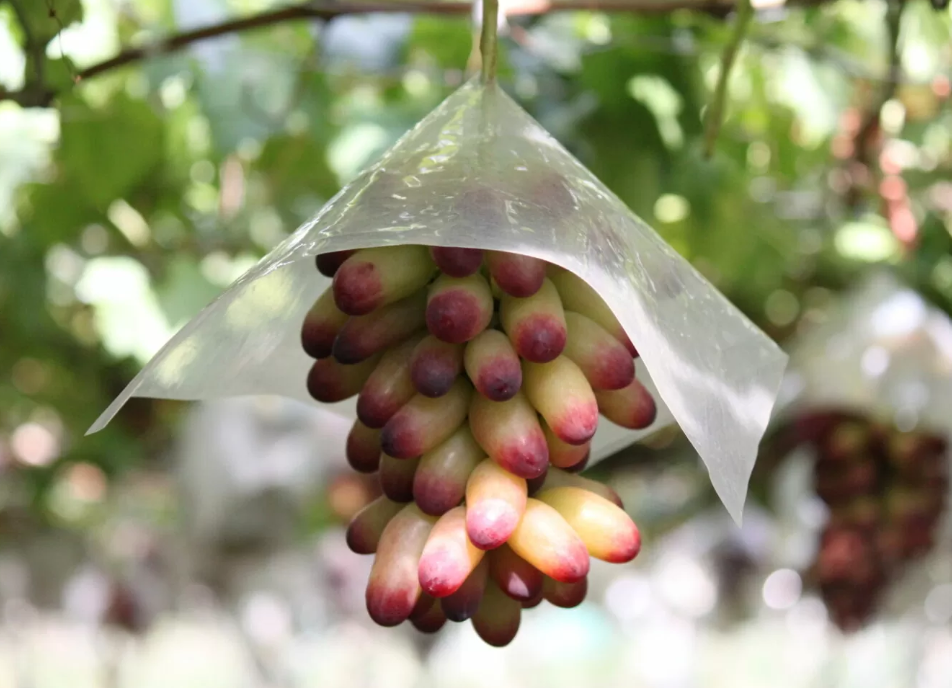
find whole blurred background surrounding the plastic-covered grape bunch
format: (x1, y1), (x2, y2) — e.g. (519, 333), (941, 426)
(0, 0), (952, 688)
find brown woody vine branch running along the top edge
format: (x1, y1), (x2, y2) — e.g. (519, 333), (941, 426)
(0, 0), (831, 107)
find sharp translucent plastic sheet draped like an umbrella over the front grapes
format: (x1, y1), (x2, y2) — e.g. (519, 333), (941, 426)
(90, 80), (786, 520)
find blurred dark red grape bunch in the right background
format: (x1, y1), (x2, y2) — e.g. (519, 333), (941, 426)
(780, 411), (949, 630)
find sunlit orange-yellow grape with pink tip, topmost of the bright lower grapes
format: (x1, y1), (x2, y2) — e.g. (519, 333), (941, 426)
(466, 459), (528, 549)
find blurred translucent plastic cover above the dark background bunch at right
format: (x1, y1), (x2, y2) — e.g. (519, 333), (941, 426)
(777, 272), (952, 437)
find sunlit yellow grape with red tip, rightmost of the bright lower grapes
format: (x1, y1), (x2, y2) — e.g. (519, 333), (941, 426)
(535, 487), (641, 564)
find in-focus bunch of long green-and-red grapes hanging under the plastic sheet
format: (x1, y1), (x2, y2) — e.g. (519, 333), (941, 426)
(301, 245), (656, 646)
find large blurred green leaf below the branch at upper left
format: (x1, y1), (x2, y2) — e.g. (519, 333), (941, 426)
(58, 95), (164, 209)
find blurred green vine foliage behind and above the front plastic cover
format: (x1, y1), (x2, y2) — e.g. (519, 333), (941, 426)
(0, 0), (952, 528)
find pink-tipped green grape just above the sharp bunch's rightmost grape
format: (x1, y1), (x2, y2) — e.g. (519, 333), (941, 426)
(562, 311), (635, 389)
